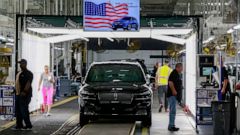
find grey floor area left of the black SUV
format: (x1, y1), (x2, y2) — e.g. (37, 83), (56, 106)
(0, 100), (78, 135)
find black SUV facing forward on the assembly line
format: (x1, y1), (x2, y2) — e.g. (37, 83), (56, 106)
(79, 61), (152, 126)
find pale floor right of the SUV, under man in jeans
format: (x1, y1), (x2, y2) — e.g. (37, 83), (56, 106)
(149, 91), (213, 135)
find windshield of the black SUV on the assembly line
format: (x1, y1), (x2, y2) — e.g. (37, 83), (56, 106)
(86, 64), (145, 84)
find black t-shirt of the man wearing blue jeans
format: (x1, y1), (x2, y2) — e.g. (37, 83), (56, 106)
(167, 69), (182, 97)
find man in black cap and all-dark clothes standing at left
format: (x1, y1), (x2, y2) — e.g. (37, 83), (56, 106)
(13, 59), (33, 130)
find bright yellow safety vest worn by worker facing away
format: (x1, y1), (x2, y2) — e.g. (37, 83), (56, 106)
(157, 65), (172, 85)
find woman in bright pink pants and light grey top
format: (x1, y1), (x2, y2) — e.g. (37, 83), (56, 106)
(38, 66), (55, 116)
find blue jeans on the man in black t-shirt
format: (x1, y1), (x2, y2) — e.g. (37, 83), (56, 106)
(168, 96), (177, 128)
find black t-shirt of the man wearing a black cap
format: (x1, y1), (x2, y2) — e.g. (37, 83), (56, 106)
(19, 70), (33, 96)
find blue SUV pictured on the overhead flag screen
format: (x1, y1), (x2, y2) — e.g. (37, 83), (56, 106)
(112, 16), (138, 30)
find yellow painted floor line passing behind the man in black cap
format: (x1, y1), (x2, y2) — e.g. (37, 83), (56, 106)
(0, 96), (78, 132)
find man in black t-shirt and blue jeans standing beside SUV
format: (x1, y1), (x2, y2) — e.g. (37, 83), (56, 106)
(167, 63), (183, 131)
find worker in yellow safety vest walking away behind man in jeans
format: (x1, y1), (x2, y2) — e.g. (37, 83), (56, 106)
(155, 60), (172, 112)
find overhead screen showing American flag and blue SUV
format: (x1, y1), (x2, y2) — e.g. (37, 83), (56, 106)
(83, 0), (140, 31)
